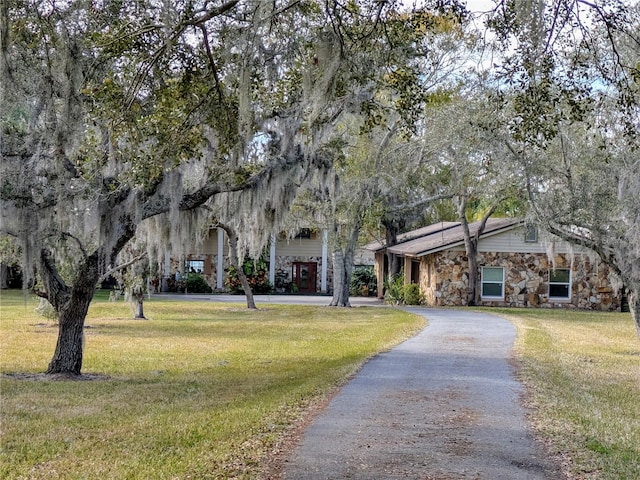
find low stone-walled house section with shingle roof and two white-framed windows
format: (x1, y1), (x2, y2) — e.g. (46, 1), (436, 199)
(369, 218), (621, 310)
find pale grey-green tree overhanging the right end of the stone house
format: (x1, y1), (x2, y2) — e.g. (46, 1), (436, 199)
(513, 105), (640, 335)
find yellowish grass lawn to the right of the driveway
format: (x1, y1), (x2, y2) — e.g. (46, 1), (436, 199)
(489, 309), (640, 480)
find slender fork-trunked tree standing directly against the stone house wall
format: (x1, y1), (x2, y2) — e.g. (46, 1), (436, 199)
(424, 88), (525, 305)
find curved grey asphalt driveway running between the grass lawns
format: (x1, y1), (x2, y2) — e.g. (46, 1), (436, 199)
(281, 308), (562, 480)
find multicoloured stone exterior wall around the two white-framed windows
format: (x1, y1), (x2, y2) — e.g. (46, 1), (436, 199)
(420, 250), (620, 310)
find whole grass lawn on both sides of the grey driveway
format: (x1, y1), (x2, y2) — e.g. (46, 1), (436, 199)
(0, 291), (640, 480)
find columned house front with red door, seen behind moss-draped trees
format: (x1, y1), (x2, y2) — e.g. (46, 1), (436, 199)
(162, 228), (332, 293)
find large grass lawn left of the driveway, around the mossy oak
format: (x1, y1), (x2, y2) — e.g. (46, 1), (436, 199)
(0, 291), (424, 479)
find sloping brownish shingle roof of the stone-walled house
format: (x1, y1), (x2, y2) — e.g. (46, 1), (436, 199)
(370, 218), (522, 257)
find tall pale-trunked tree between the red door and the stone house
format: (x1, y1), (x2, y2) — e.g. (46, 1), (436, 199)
(282, 3), (469, 306)
